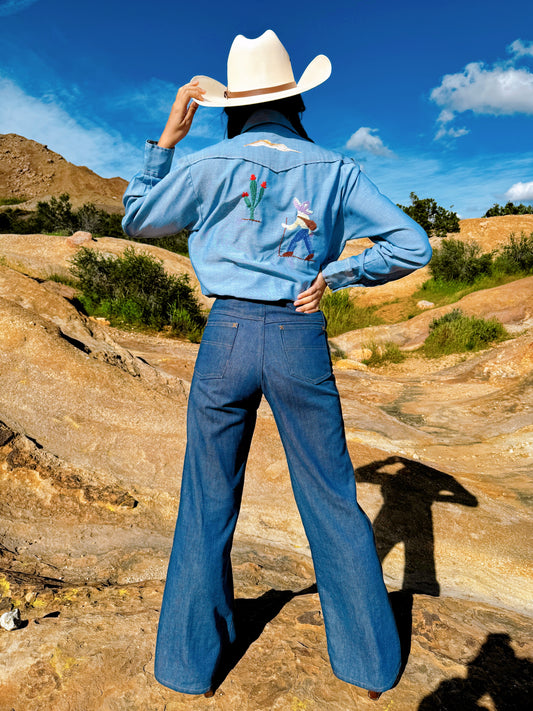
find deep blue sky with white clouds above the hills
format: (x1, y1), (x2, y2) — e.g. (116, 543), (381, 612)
(0, 0), (533, 217)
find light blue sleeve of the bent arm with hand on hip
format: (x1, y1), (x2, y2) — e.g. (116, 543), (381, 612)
(322, 163), (431, 291)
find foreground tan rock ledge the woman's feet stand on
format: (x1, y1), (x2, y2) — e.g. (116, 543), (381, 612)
(0, 572), (533, 711)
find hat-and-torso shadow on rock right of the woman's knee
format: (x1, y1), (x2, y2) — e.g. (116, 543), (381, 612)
(355, 456), (478, 596)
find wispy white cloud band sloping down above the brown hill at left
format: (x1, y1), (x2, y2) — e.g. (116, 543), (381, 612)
(0, 77), (142, 178)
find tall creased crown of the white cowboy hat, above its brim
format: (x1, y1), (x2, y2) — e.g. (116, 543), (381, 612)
(228, 30), (295, 92)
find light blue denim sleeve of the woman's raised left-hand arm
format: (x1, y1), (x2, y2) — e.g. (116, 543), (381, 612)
(122, 141), (200, 237)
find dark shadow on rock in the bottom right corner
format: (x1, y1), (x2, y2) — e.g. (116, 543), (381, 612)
(418, 633), (533, 711)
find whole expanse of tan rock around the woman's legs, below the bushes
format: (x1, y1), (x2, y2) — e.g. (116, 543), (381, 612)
(0, 243), (533, 711)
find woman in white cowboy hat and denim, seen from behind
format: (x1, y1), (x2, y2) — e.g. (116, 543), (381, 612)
(123, 30), (431, 698)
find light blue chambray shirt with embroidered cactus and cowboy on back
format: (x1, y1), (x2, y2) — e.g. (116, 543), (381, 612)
(122, 109), (431, 301)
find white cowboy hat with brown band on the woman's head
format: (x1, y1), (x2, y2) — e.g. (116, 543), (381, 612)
(191, 30), (331, 106)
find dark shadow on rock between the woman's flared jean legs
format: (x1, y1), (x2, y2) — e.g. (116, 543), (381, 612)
(213, 584), (317, 688)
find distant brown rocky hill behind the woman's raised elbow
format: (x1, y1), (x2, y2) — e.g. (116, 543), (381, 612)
(0, 133), (127, 212)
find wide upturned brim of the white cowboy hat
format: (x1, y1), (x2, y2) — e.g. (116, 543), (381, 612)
(191, 54), (331, 108)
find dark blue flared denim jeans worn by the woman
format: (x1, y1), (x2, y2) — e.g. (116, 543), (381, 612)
(155, 298), (400, 694)
